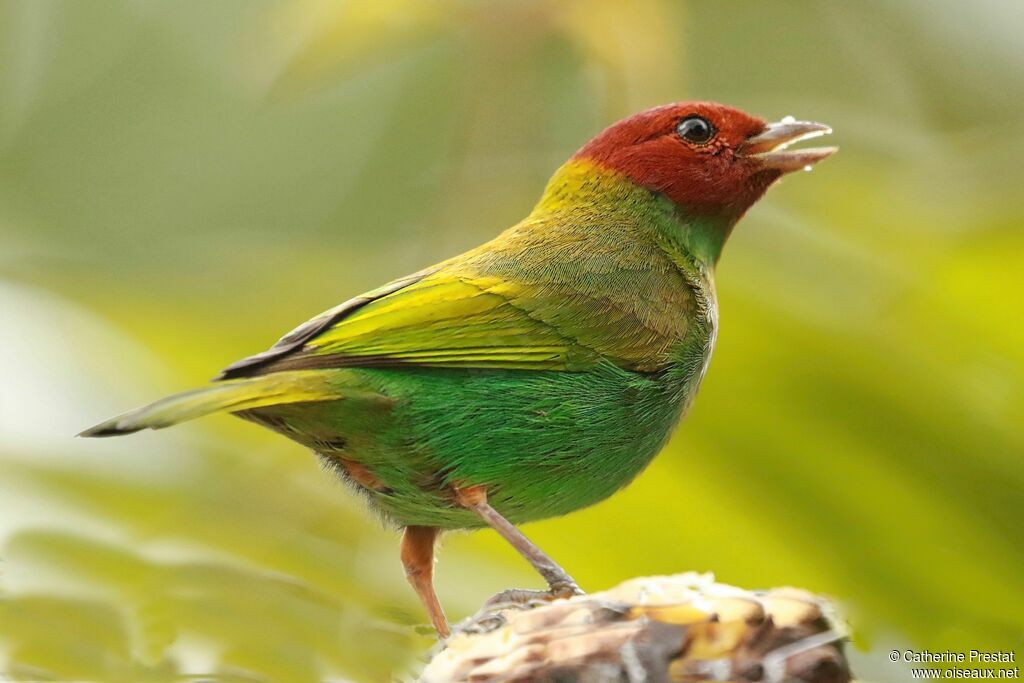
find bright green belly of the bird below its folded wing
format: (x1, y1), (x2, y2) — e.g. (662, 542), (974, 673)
(250, 366), (695, 528)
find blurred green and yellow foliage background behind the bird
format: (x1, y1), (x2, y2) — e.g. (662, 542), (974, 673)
(0, 0), (1024, 681)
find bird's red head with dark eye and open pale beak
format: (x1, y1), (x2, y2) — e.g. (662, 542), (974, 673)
(573, 102), (836, 221)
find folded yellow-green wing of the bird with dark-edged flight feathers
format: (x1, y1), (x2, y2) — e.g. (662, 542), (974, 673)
(225, 272), (601, 377)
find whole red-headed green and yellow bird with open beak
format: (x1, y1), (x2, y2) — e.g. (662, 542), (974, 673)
(81, 101), (837, 638)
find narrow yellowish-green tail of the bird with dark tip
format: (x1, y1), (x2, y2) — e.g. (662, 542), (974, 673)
(79, 370), (341, 436)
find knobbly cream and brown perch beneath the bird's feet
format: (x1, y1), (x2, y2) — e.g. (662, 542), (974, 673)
(421, 572), (851, 683)
